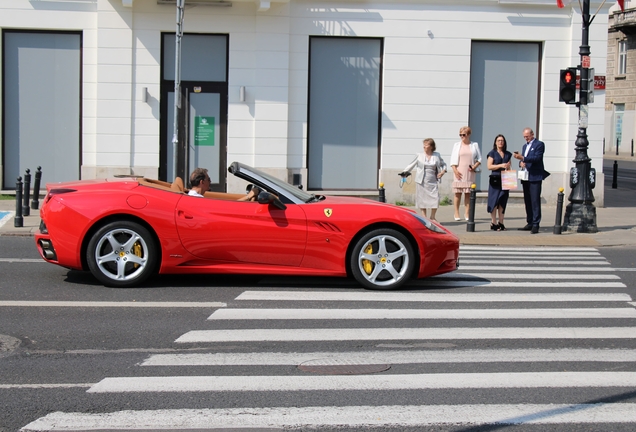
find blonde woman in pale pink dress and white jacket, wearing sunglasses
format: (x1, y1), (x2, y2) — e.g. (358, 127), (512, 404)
(451, 126), (481, 220)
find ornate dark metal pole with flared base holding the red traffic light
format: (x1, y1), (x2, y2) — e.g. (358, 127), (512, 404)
(563, 0), (598, 233)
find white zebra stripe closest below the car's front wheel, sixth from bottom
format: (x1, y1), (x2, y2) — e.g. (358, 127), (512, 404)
(236, 290), (632, 303)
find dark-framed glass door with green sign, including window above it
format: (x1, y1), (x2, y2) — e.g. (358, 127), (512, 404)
(159, 33), (229, 192)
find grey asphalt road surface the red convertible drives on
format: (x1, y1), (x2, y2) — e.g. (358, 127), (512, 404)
(0, 237), (636, 432)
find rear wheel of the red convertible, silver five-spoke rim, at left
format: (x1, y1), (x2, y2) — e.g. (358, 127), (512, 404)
(87, 221), (158, 288)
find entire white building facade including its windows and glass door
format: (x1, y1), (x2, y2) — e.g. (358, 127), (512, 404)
(0, 0), (612, 206)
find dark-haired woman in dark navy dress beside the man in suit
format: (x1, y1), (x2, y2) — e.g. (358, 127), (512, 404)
(486, 134), (512, 231)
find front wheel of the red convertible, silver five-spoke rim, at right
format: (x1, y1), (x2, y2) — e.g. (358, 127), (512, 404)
(351, 228), (415, 289)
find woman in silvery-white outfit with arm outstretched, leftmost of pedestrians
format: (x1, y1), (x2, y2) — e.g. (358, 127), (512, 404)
(404, 138), (446, 220)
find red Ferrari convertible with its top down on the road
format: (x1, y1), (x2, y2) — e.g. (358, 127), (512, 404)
(35, 162), (459, 289)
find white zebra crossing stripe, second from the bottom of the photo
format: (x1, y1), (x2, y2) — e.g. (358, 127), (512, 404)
(87, 372), (636, 393)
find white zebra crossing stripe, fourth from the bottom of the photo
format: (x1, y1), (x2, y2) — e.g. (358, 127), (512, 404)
(175, 327), (636, 343)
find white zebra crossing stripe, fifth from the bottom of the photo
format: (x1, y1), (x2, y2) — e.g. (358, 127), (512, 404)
(208, 307), (636, 320)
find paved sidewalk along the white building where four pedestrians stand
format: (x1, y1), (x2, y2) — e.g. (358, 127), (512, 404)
(0, 196), (636, 247)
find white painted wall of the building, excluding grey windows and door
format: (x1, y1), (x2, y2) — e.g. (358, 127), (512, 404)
(0, 0), (613, 205)
